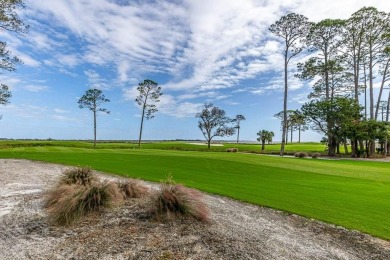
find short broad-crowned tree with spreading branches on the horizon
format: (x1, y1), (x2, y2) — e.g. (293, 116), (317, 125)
(195, 104), (235, 149)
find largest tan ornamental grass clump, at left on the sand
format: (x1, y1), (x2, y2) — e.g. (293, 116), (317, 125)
(45, 182), (123, 225)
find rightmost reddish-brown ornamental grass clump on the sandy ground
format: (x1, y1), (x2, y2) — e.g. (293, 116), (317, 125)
(152, 184), (209, 222)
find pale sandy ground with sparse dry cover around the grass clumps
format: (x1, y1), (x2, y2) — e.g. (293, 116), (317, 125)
(0, 159), (390, 259)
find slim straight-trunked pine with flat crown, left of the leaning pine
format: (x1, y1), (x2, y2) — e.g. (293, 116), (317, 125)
(78, 89), (110, 147)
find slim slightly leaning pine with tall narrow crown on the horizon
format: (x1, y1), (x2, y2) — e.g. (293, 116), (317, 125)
(135, 79), (163, 148)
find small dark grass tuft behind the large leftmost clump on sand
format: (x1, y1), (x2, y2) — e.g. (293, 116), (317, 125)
(60, 167), (97, 186)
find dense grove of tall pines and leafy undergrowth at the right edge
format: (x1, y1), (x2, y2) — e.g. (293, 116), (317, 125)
(270, 7), (390, 157)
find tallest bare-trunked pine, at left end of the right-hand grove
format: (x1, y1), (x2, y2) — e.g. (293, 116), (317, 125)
(269, 13), (310, 156)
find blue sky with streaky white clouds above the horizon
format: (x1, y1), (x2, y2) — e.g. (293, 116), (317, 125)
(0, 0), (390, 141)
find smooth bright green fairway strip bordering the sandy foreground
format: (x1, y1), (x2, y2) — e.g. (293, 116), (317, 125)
(0, 146), (390, 240)
